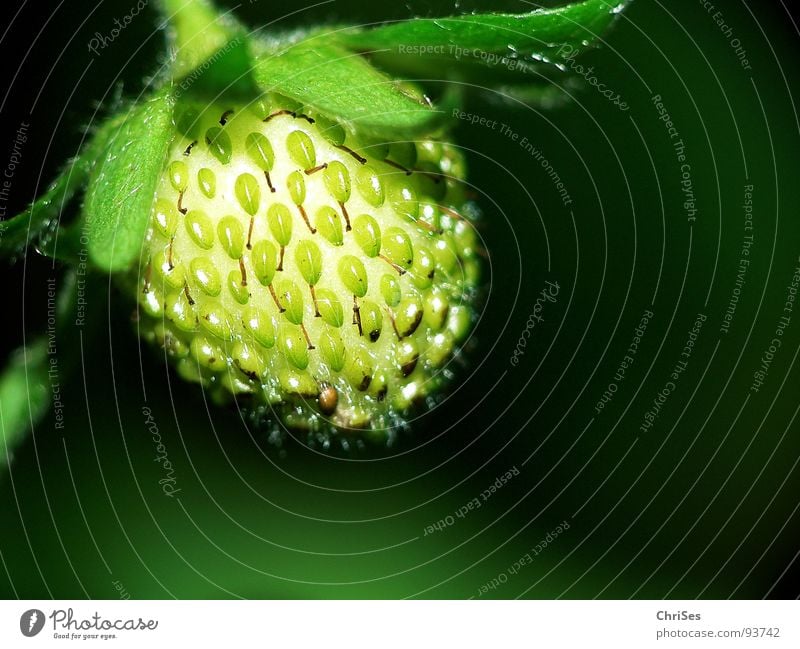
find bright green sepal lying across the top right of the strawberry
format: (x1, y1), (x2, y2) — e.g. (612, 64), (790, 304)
(253, 36), (439, 137)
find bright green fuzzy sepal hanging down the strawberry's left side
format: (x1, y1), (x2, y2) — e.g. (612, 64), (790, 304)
(84, 90), (174, 271)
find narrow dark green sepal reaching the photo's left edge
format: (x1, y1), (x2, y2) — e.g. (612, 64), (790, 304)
(0, 122), (113, 257)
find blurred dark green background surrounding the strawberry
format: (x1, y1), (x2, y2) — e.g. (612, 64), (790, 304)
(0, 0), (800, 598)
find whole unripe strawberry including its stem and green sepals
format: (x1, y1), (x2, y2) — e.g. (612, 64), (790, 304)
(0, 0), (629, 460)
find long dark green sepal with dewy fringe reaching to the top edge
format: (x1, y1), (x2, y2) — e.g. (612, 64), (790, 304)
(341, 0), (631, 77)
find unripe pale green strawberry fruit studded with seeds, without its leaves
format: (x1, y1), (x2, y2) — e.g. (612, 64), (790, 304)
(134, 96), (480, 443)
